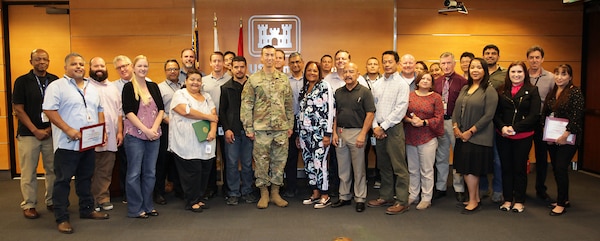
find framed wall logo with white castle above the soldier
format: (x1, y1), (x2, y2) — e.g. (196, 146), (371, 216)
(248, 15), (301, 57)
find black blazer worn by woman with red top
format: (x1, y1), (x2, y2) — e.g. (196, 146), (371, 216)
(494, 85), (542, 133)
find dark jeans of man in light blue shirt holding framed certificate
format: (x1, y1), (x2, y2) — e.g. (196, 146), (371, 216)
(52, 149), (96, 223)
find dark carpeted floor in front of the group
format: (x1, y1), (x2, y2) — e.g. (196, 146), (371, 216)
(0, 168), (600, 241)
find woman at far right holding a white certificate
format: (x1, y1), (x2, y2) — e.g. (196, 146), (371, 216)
(542, 64), (585, 216)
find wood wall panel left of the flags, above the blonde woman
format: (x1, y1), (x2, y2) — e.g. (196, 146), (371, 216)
(70, 0), (192, 82)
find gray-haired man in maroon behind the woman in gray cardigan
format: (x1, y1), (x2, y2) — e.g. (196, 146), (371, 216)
(433, 52), (467, 202)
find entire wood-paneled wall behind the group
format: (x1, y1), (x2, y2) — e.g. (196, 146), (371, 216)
(0, 0), (583, 169)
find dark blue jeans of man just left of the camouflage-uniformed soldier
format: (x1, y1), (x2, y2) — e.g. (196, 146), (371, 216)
(225, 131), (254, 197)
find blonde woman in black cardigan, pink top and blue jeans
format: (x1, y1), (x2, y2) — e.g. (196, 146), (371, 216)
(121, 55), (164, 218)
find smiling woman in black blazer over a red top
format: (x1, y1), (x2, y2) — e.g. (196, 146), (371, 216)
(494, 61), (541, 213)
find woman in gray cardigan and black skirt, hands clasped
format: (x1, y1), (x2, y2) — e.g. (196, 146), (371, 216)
(452, 58), (498, 214)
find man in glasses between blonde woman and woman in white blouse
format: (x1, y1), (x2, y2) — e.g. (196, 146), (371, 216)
(153, 59), (185, 205)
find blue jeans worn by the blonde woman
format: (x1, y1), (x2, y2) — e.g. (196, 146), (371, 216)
(123, 135), (160, 217)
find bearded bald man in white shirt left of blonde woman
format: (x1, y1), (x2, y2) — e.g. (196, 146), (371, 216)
(89, 57), (123, 211)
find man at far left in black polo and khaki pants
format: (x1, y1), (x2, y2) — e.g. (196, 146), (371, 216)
(12, 49), (58, 219)
